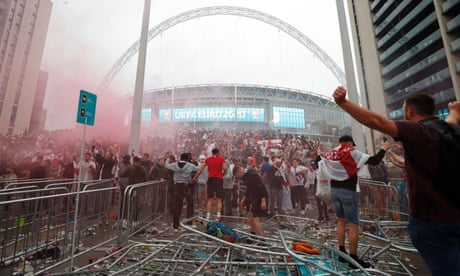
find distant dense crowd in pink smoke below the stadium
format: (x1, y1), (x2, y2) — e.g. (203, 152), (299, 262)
(0, 126), (326, 178)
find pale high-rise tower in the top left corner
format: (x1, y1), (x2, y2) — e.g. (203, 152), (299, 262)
(0, 0), (52, 134)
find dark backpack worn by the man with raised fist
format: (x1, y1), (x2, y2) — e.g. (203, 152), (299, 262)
(423, 120), (460, 209)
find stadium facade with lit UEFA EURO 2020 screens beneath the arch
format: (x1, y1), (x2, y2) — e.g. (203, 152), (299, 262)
(137, 84), (351, 142)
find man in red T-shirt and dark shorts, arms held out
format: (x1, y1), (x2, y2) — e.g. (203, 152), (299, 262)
(193, 148), (228, 221)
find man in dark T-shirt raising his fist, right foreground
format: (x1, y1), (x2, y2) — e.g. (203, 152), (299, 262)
(333, 87), (460, 275)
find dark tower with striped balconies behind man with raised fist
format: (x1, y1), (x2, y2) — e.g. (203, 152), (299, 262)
(348, 0), (460, 151)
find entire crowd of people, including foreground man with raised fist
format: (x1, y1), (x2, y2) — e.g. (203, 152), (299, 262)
(0, 87), (460, 275)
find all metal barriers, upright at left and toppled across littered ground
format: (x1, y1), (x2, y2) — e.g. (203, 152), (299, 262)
(0, 178), (420, 275)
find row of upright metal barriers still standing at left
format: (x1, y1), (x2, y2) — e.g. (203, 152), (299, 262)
(0, 179), (168, 275)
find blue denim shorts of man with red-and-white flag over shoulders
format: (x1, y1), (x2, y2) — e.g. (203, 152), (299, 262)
(331, 188), (359, 224)
